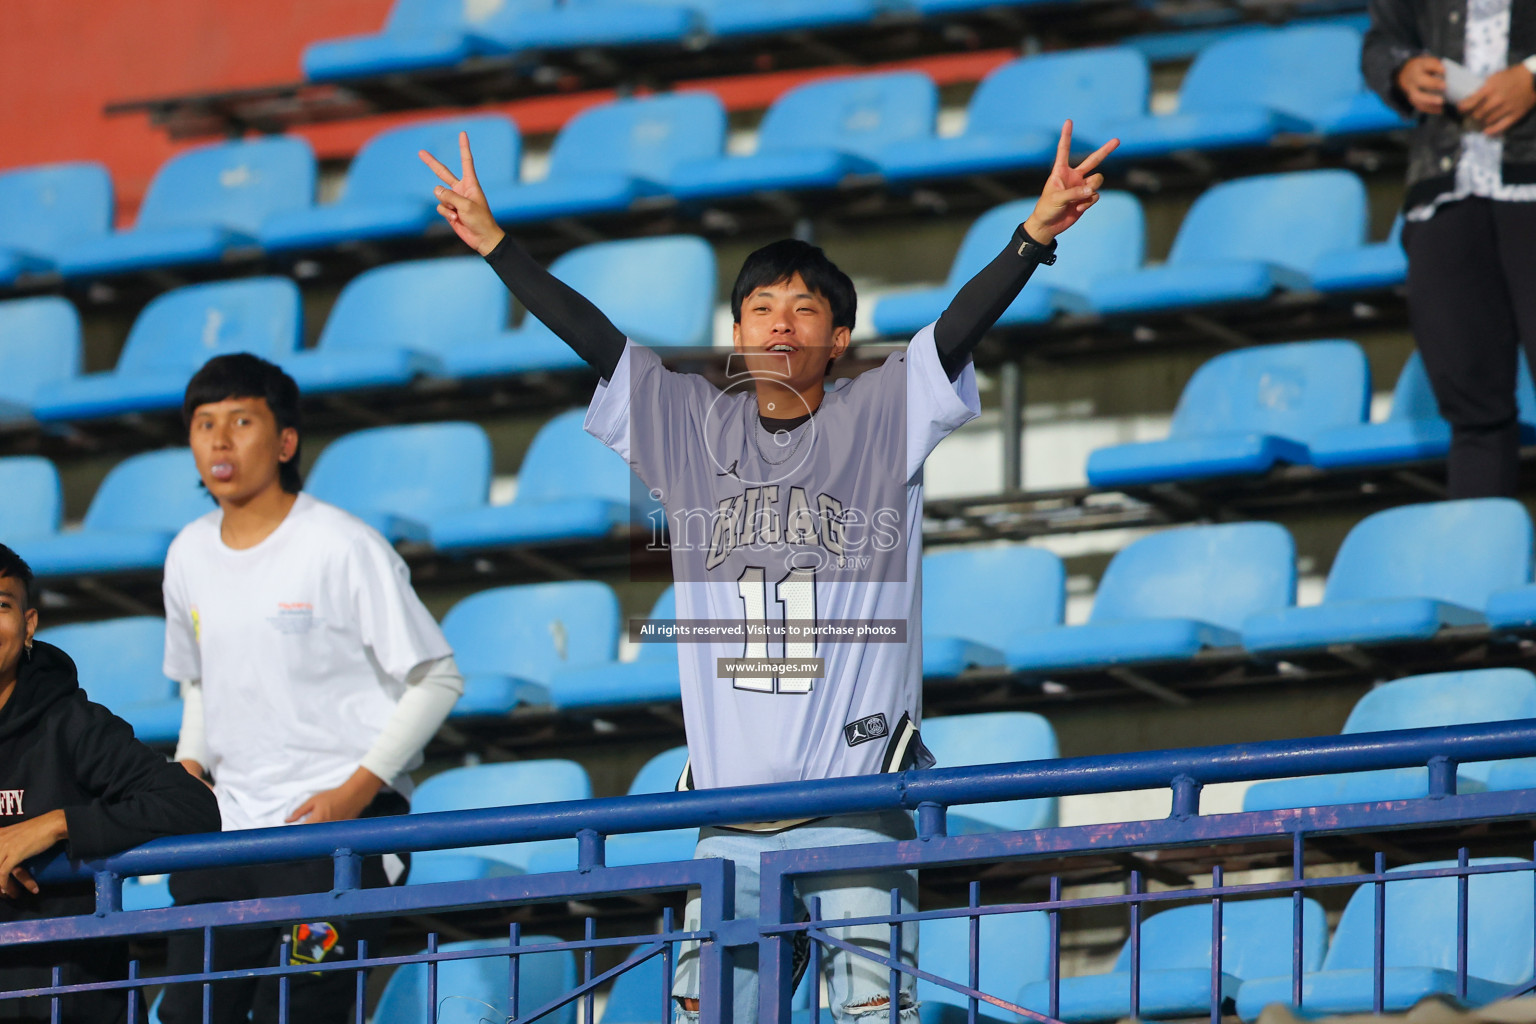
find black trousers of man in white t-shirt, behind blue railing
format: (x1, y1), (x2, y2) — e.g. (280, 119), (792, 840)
(160, 792), (410, 1024)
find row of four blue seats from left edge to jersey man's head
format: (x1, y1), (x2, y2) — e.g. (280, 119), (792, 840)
(0, 235), (716, 424)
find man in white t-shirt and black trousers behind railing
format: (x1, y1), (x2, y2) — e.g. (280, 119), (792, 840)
(160, 355), (464, 1024)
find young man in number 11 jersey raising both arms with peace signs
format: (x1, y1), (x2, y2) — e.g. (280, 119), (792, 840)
(421, 123), (1118, 1024)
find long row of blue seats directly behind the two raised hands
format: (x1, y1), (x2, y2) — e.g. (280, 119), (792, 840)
(0, 25), (1402, 284)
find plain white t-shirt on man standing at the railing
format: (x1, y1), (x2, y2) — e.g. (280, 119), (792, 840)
(164, 494), (452, 831)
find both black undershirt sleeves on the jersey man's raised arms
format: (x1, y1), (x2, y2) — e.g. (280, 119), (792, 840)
(485, 227), (1055, 396)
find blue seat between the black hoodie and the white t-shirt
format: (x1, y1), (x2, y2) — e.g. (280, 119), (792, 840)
(37, 616), (181, 743)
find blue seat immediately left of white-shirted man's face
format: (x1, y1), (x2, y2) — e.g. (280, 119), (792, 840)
(15, 448), (215, 577)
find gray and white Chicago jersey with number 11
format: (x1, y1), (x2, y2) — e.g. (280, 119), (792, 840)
(585, 325), (980, 788)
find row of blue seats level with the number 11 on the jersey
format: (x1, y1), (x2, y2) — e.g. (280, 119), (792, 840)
(33, 499), (1536, 743)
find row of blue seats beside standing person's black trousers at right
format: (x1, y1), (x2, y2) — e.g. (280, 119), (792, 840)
(1087, 341), (1505, 487)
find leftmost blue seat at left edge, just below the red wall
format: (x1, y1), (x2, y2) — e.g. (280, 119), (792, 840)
(0, 163), (112, 286)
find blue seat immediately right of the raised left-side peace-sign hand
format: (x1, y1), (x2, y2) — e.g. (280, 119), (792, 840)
(485, 92), (725, 224)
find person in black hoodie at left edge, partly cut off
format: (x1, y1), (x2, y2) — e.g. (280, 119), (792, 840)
(0, 543), (220, 1024)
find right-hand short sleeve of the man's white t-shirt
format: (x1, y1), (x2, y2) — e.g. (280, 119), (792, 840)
(347, 531), (453, 683)
